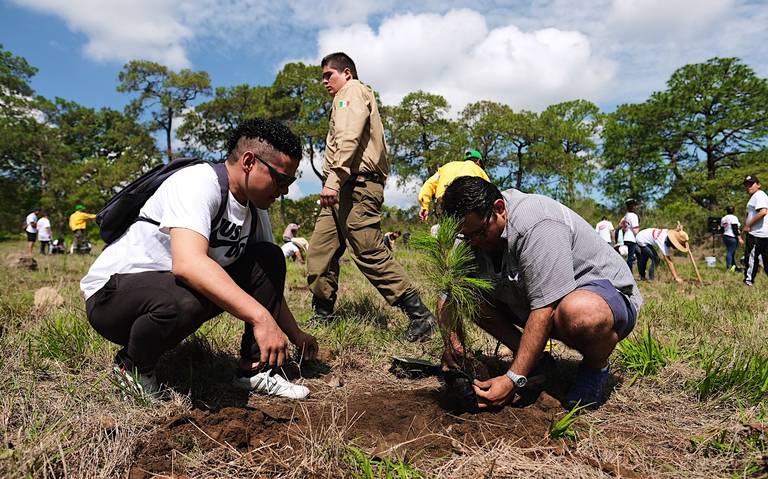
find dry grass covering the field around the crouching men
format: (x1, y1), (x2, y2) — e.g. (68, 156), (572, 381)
(0, 243), (768, 478)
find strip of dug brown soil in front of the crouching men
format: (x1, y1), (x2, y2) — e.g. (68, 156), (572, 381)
(130, 388), (562, 479)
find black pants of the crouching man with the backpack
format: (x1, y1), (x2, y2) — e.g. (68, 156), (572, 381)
(86, 243), (285, 373)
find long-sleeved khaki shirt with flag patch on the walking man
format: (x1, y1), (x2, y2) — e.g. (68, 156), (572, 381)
(323, 79), (389, 191)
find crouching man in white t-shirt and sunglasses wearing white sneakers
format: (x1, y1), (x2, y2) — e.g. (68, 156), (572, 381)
(80, 119), (317, 398)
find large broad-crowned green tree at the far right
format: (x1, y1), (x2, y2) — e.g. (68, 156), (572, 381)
(605, 58), (768, 212)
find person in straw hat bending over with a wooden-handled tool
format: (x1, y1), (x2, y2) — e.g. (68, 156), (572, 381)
(635, 223), (688, 283)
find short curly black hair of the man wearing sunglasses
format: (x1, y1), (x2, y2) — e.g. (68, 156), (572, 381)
(227, 118), (301, 161)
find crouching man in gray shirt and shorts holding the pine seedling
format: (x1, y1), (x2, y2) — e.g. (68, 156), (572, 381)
(440, 177), (643, 409)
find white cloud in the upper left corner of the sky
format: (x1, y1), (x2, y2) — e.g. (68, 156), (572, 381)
(15, 0), (192, 68)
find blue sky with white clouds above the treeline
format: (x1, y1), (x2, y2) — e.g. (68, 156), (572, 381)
(0, 0), (768, 206)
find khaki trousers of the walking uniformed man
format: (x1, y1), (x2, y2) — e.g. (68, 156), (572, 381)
(307, 180), (411, 304)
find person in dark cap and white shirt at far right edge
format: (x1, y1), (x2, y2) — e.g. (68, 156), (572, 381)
(743, 175), (768, 286)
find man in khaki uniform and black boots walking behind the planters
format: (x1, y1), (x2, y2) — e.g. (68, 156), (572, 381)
(307, 53), (436, 341)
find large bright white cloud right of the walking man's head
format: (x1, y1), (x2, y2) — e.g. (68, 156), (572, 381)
(318, 9), (616, 109)
